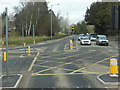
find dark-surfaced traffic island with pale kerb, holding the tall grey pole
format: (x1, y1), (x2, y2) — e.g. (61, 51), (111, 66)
(0, 74), (23, 88)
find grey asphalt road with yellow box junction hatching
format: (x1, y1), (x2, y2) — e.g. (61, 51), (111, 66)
(3, 36), (118, 88)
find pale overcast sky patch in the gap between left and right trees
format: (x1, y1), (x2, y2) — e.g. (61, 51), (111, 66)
(47, 0), (97, 24)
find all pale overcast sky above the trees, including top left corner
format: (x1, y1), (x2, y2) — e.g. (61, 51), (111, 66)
(0, 0), (103, 24)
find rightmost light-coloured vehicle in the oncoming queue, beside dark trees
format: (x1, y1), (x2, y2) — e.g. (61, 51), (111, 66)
(96, 35), (109, 46)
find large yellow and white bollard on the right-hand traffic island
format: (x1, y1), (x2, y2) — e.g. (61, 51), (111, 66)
(110, 58), (118, 77)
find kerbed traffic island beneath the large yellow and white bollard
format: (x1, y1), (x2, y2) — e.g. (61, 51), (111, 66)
(97, 73), (120, 86)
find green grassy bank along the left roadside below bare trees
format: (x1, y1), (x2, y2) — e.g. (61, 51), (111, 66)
(2, 34), (66, 46)
